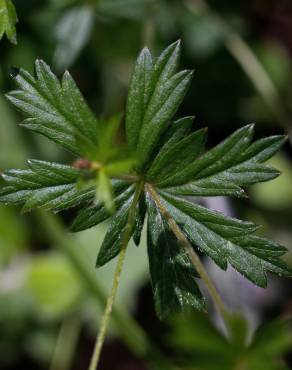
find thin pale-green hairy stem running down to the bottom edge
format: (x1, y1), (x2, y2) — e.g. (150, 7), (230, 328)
(89, 182), (143, 370)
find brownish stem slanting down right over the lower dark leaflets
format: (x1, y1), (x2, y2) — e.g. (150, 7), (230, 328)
(145, 183), (229, 332)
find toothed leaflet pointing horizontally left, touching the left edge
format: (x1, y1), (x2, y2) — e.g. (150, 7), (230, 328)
(0, 160), (94, 212)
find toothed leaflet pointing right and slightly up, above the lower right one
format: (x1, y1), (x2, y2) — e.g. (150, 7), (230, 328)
(157, 126), (286, 197)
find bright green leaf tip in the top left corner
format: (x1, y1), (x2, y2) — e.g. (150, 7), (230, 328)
(0, 0), (18, 44)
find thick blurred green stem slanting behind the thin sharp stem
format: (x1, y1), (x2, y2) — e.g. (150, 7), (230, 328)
(38, 211), (176, 370)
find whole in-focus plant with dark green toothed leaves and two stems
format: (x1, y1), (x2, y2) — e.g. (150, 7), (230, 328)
(0, 42), (292, 370)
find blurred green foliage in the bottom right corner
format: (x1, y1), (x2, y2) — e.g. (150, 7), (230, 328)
(167, 312), (292, 370)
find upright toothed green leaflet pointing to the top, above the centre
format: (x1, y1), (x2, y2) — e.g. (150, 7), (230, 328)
(126, 42), (192, 167)
